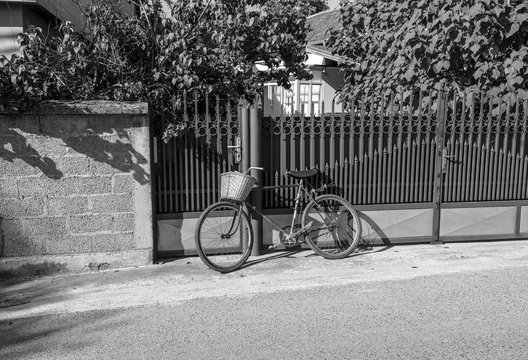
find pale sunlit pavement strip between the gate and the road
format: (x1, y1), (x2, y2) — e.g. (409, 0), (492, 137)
(0, 241), (528, 321)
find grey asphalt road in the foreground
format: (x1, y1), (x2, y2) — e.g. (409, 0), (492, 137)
(0, 264), (528, 360)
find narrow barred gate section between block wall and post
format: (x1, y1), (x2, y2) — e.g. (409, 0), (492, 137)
(152, 97), (239, 214)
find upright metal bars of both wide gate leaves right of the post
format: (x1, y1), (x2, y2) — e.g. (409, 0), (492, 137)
(263, 90), (528, 208)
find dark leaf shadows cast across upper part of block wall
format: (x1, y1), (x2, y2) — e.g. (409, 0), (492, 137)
(0, 106), (150, 185)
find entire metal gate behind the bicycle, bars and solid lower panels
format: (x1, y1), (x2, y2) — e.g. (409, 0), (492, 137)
(153, 92), (528, 256)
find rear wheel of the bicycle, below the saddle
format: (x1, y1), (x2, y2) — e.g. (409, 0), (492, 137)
(302, 194), (361, 259)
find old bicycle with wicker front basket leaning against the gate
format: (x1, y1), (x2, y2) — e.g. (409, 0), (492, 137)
(195, 167), (361, 273)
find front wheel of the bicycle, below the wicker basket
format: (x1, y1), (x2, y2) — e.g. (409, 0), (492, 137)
(194, 201), (253, 273)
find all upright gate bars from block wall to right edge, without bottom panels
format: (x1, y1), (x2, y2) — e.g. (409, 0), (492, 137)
(153, 93), (528, 214)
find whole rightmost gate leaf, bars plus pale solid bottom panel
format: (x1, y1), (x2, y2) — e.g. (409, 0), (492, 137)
(433, 93), (528, 241)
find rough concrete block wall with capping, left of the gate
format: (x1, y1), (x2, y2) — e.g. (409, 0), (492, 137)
(0, 102), (153, 277)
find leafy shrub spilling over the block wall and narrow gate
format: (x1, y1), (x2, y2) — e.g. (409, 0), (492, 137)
(0, 0), (309, 114)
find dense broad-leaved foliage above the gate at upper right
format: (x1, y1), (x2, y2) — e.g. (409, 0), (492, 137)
(327, 0), (528, 107)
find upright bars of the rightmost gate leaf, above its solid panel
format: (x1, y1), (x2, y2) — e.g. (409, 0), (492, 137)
(442, 94), (528, 203)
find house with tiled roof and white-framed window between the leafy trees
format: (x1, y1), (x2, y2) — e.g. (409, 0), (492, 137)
(257, 9), (344, 116)
